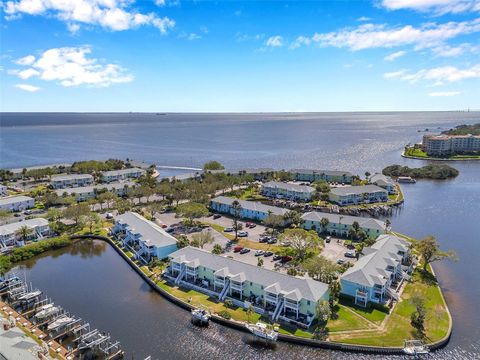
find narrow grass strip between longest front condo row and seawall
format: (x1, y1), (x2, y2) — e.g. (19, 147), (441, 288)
(156, 280), (262, 323)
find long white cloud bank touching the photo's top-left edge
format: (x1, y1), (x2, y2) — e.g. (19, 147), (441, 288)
(3, 0), (175, 33)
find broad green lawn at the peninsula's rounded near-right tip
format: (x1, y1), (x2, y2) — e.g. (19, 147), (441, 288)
(330, 269), (450, 347)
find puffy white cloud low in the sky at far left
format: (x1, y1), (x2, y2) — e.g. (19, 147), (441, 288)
(11, 46), (133, 87)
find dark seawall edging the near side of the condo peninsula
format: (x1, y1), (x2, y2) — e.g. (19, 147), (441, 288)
(70, 235), (453, 355)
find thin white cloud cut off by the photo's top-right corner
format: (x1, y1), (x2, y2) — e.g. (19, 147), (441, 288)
(382, 0), (480, 15)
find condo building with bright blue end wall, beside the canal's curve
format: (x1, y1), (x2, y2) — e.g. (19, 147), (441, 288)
(111, 212), (177, 263)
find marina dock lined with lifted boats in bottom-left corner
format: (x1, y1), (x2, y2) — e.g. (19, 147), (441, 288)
(0, 275), (124, 360)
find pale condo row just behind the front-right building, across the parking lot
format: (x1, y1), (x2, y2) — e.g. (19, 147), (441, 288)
(301, 211), (387, 239)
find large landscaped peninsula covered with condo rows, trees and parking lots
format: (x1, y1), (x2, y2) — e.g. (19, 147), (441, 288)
(0, 160), (454, 351)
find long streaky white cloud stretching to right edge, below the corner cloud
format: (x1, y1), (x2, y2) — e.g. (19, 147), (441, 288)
(294, 18), (480, 51)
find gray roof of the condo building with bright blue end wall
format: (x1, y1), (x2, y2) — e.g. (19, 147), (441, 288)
(116, 212), (177, 247)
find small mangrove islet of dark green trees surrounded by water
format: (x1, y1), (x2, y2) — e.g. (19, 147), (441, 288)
(382, 164), (459, 180)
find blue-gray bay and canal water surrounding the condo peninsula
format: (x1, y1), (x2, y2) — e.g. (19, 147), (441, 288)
(0, 113), (480, 359)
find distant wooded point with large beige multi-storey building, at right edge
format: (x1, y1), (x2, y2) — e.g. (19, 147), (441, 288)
(402, 123), (480, 160)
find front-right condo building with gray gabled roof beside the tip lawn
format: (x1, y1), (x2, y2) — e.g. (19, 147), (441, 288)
(340, 235), (414, 306)
